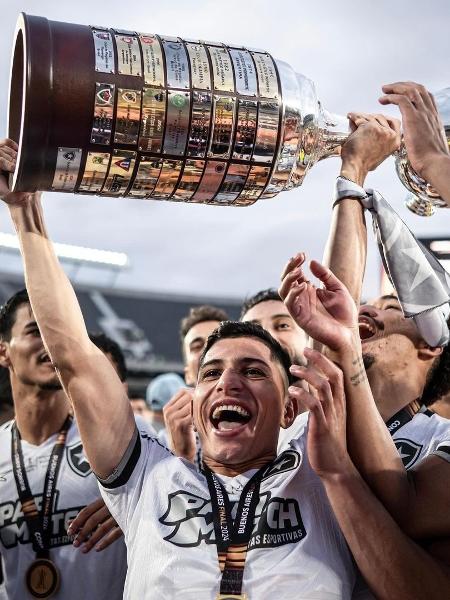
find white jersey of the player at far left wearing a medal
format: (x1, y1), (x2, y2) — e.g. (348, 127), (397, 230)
(0, 421), (127, 600)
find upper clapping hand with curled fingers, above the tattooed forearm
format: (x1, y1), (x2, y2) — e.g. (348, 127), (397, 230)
(278, 253), (359, 351)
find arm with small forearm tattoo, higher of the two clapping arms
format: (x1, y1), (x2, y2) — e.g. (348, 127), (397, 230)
(279, 255), (450, 538)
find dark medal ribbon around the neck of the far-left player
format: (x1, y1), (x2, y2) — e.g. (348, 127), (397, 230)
(11, 415), (72, 558)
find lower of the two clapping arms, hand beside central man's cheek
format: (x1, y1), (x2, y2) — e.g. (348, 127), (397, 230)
(289, 348), (450, 600)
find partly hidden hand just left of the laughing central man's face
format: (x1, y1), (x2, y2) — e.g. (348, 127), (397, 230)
(163, 389), (196, 462)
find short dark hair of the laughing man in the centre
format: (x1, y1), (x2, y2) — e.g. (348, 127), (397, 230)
(200, 321), (295, 384)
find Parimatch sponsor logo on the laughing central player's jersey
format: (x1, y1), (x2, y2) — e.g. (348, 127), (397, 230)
(159, 490), (306, 549)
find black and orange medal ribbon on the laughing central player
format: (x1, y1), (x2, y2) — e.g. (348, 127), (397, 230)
(204, 465), (267, 598)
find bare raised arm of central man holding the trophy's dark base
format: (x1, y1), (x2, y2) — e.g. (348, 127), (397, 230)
(0, 141), (136, 478)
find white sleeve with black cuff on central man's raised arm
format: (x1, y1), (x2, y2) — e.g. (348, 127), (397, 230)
(97, 427), (174, 532)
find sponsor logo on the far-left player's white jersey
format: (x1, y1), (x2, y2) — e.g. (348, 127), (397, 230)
(0, 490), (84, 549)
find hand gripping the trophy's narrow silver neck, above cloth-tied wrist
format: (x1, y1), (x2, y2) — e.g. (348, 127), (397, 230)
(341, 113), (400, 186)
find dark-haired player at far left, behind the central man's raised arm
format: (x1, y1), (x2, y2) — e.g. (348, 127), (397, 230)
(0, 291), (126, 600)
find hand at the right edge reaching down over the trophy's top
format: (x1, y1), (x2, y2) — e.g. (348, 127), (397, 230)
(379, 82), (450, 183)
